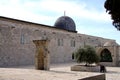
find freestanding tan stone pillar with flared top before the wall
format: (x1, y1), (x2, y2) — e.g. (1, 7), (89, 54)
(33, 40), (50, 70)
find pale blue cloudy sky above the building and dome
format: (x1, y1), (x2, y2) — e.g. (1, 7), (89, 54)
(0, 0), (120, 44)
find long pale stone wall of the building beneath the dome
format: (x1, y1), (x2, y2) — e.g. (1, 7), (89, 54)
(0, 17), (120, 67)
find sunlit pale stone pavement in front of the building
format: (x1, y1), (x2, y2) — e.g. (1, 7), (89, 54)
(0, 63), (120, 80)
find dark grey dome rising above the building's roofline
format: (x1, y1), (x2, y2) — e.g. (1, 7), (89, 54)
(54, 16), (76, 31)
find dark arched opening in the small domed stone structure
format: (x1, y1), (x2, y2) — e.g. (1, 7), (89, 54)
(100, 48), (113, 62)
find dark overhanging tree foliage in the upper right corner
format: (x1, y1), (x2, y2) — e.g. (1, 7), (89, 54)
(104, 0), (120, 31)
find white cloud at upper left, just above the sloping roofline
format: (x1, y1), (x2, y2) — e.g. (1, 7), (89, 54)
(0, 0), (53, 23)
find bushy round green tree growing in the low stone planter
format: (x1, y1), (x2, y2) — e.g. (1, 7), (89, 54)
(74, 46), (100, 66)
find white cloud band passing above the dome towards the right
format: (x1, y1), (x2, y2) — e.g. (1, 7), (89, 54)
(38, 0), (110, 22)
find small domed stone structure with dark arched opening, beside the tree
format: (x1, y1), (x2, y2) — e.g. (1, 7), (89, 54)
(96, 41), (119, 66)
